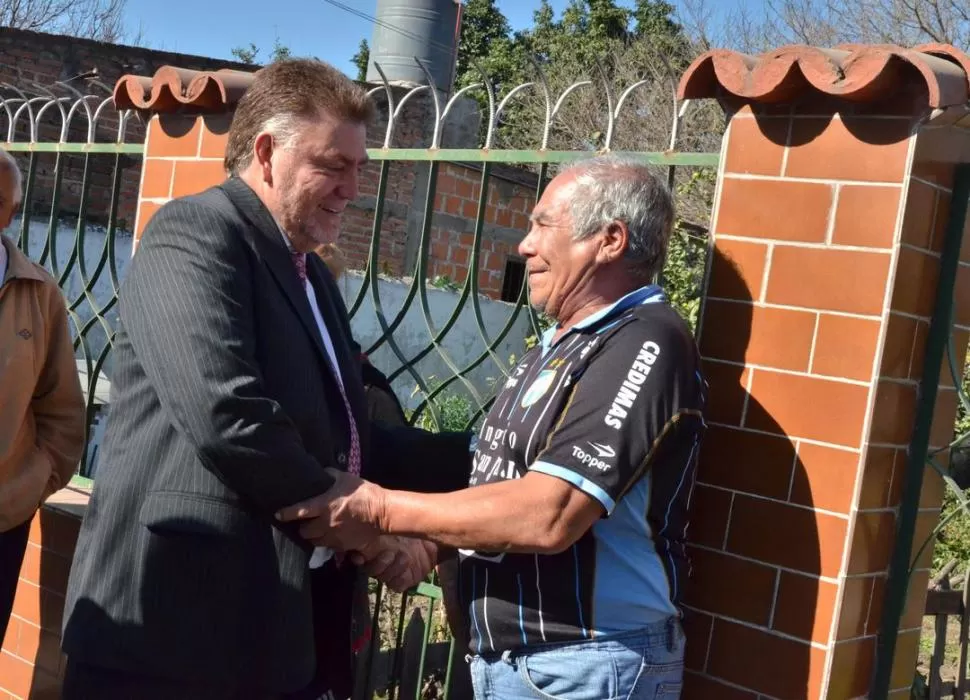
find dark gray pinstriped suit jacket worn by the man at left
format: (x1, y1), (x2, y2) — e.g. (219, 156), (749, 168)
(63, 178), (470, 697)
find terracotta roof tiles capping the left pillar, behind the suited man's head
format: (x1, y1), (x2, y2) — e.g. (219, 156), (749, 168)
(114, 66), (253, 112)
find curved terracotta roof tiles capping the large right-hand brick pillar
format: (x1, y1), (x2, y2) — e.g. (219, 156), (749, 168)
(678, 44), (970, 107)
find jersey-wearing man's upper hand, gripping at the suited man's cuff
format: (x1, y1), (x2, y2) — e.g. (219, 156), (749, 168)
(276, 469), (383, 558)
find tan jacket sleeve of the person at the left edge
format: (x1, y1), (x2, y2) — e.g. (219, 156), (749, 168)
(31, 291), (84, 495)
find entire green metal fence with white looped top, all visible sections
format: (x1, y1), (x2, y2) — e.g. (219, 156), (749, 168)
(13, 60), (970, 700)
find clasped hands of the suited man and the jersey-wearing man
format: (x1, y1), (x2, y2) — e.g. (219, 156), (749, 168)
(276, 469), (437, 592)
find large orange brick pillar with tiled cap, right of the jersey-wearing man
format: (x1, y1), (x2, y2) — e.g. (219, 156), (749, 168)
(681, 47), (970, 700)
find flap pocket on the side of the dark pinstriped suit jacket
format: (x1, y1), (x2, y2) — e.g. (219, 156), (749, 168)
(138, 491), (255, 537)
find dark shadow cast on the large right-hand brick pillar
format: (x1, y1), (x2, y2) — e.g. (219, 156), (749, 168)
(683, 247), (820, 700)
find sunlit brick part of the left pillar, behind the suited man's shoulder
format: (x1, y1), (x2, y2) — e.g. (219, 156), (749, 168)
(135, 114), (232, 247)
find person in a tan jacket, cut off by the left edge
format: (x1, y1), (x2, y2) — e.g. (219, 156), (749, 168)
(0, 150), (84, 639)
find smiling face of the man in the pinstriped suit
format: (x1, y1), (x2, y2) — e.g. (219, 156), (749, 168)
(254, 109), (367, 253)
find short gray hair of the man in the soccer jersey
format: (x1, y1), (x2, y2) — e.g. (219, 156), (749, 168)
(560, 154), (674, 280)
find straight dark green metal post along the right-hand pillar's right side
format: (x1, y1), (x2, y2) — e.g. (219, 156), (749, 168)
(869, 164), (970, 699)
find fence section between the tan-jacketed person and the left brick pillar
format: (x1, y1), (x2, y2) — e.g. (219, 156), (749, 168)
(0, 82), (144, 474)
